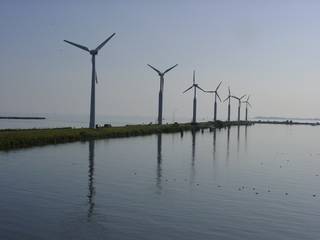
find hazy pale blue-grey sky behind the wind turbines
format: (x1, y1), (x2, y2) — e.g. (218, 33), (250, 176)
(0, 0), (320, 120)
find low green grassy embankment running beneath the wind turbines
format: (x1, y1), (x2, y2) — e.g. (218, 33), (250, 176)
(0, 121), (250, 150)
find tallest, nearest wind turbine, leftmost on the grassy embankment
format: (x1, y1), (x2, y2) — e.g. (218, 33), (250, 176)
(64, 33), (115, 128)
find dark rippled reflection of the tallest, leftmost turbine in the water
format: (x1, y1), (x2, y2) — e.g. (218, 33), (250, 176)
(88, 140), (96, 220)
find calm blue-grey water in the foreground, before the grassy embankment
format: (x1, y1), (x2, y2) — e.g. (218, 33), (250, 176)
(0, 125), (320, 240)
